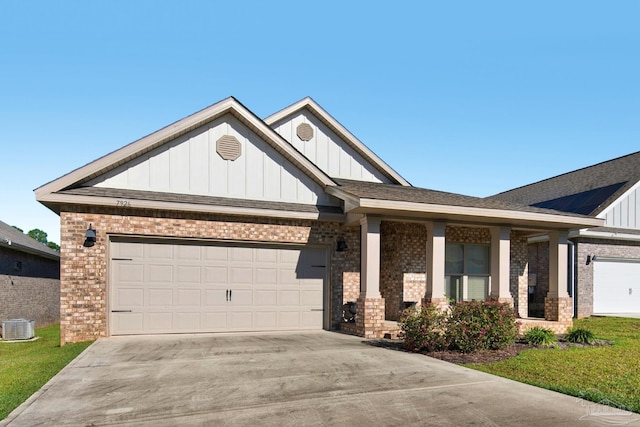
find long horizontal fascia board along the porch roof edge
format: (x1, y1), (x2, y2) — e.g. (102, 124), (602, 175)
(359, 199), (604, 228)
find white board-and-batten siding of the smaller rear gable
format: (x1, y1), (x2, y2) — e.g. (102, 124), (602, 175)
(273, 111), (391, 183)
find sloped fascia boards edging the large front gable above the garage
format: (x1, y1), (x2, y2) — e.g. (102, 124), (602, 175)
(34, 97), (335, 200)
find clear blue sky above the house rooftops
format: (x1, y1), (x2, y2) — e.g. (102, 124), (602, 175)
(0, 0), (640, 246)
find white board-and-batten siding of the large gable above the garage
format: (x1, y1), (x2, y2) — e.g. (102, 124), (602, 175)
(89, 115), (337, 206)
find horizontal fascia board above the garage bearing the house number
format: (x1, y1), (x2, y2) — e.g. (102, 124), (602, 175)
(38, 194), (345, 222)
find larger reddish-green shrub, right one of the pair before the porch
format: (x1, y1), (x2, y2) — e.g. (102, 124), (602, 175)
(447, 301), (518, 353)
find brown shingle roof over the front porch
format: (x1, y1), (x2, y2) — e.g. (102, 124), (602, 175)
(334, 178), (582, 217)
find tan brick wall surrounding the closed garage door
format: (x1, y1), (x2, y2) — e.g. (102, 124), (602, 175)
(60, 206), (360, 344)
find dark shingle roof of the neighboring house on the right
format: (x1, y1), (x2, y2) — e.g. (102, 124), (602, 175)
(487, 151), (640, 216)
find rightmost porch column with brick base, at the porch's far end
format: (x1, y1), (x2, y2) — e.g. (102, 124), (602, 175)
(544, 230), (573, 324)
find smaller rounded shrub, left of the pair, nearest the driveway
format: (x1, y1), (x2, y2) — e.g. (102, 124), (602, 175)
(400, 305), (449, 351)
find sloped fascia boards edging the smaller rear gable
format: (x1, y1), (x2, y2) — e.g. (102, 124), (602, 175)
(264, 97), (411, 187)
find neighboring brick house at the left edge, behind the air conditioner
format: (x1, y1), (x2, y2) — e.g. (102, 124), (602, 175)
(0, 221), (60, 328)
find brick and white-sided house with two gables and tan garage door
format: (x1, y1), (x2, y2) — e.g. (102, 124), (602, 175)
(35, 97), (604, 344)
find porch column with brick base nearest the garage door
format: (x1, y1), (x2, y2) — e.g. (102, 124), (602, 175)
(356, 215), (385, 338)
